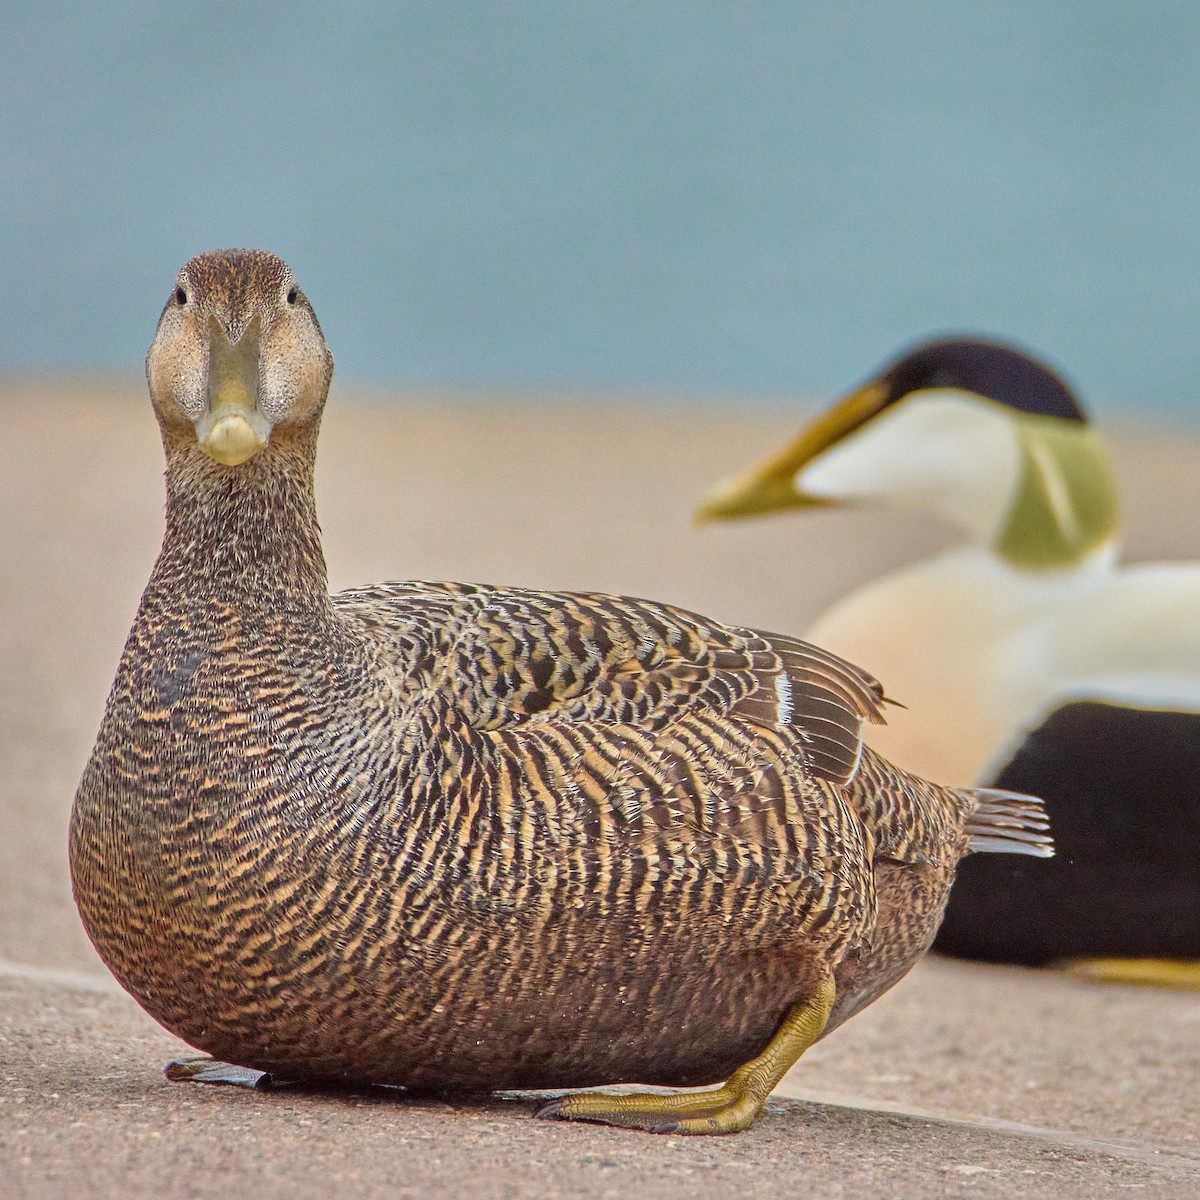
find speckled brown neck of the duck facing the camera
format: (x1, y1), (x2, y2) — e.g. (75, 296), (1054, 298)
(146, 438), (329, 613)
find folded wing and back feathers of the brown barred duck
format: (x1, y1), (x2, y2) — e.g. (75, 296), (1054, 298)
(335, 582), (883, 785)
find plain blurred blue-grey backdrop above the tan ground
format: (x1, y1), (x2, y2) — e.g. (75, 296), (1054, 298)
(0, 0), (1200, 420)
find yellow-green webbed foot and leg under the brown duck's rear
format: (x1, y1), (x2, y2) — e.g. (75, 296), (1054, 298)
(536, 979), (834, 1133)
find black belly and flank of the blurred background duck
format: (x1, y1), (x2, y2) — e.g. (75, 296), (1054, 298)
(934, 701), (1200, 966)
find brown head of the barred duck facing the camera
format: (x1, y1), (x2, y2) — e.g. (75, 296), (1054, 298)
(146, 250), (334, 468)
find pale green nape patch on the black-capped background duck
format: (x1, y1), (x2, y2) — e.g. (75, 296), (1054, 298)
(991, 415), (1120, 571)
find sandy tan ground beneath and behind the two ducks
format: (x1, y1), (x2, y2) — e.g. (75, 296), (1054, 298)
(0, 380), (1200, 1200)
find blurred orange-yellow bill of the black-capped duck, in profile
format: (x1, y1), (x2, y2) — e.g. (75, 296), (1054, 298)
(696, 383), (888, 523)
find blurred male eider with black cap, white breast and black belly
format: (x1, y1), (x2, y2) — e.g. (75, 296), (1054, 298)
(698, 338), (1200, 986)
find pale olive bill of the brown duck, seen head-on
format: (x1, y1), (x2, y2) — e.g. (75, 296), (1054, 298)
(196, 313), (271, 467)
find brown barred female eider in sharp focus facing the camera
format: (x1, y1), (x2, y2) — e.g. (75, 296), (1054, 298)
(71, 260), (1051, 1133)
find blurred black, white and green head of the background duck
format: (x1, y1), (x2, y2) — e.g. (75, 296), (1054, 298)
(696, 338), (1117, 569)
